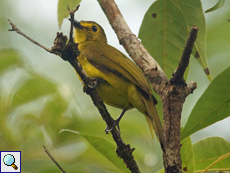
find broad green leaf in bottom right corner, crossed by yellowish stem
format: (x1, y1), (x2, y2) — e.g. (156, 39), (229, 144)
(193, 137), (230, 172)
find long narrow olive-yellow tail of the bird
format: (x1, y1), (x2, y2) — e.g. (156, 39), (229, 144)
(142, 95), (164, 151)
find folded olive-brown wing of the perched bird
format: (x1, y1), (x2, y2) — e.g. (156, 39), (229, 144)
(80, 43), (150, 93)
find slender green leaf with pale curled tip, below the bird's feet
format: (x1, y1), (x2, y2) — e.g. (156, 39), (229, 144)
(61, 130), (130, 173)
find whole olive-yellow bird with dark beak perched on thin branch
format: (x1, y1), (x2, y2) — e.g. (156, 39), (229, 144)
(73, 20), (164, 149)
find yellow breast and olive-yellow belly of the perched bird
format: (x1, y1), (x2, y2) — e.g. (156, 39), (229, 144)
(78, 55), (139, 109)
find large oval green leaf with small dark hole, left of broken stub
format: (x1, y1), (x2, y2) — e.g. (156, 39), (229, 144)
(139, 0), (189, 78)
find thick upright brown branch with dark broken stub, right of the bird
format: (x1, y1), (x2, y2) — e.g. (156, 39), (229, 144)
(162, 26), (198, 172)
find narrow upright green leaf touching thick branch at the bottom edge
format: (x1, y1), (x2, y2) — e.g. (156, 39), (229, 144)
(181, 137), (194, 173)
